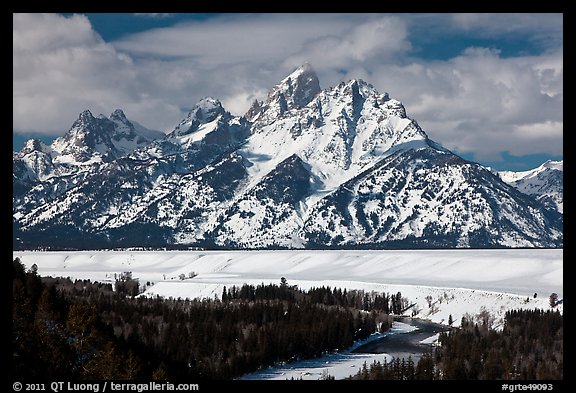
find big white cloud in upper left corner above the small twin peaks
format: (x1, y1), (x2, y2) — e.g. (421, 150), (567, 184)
(13, 14), (182, 135)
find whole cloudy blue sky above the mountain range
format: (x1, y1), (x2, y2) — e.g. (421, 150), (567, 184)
(13, 13), (563, 170)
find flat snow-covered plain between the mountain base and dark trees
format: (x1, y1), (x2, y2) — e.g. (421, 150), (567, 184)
(13, 249), (563, 327)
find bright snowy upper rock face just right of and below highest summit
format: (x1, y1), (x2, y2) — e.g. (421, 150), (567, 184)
(240, 68), (428, 194)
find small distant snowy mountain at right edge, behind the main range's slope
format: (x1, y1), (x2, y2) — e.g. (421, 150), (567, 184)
(499, 161), (564, 213)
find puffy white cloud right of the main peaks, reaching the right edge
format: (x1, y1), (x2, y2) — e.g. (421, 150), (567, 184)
(373, 48), (563, 160)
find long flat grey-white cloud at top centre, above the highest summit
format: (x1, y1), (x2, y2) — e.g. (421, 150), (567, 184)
(114, 14), (353, 62)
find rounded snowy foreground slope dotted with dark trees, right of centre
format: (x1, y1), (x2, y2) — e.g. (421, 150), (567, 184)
(304, 149), (562, 247)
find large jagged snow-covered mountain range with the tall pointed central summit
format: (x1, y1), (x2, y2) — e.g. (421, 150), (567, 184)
(14, 64), (563, 248)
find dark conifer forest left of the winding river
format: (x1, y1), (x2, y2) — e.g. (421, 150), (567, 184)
(12, 258), (398, 380)
